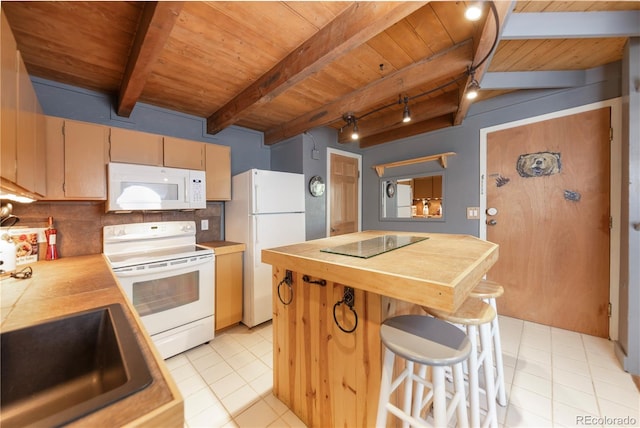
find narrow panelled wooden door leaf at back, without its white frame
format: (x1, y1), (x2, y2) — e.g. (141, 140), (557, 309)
(329, 153), (359, 236)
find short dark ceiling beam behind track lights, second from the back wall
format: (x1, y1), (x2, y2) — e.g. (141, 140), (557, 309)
(338, 88), (459, 143)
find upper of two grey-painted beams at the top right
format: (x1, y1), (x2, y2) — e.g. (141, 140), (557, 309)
(501, 10), (640, 40)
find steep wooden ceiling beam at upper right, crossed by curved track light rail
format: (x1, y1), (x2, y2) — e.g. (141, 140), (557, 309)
(454, 1), (515, 125)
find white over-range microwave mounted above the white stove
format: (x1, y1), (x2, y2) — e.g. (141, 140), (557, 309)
(106, 162), (207, 212)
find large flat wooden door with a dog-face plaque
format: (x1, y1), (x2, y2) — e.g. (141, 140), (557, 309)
(487, 107), (610, 337)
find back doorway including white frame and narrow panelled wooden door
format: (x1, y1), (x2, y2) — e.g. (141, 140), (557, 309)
(327, 148), (362, 236)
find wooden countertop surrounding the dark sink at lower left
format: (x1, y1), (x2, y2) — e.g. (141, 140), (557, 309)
(0, 255), (184, 427)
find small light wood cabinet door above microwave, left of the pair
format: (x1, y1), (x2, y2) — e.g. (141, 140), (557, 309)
(109, 128), (164, 166)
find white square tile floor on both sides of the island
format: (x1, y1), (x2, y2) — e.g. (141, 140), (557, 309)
(166, 317), (640, 428)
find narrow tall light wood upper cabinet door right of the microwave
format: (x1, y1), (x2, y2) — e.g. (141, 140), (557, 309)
(205, 144), (231, 201)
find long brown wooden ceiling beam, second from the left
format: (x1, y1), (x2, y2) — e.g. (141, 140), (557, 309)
(207, 1), (427, 134)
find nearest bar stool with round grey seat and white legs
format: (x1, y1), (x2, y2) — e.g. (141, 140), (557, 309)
(376, 315), (471, 427)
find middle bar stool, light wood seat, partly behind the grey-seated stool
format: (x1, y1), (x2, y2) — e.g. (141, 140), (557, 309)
(422, 298), (498, 428)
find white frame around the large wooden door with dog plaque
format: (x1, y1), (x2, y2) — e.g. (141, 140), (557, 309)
(478, 97), (622, 340)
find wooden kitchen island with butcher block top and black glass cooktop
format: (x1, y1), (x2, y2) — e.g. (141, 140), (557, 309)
(262, 231), (498, 427)
